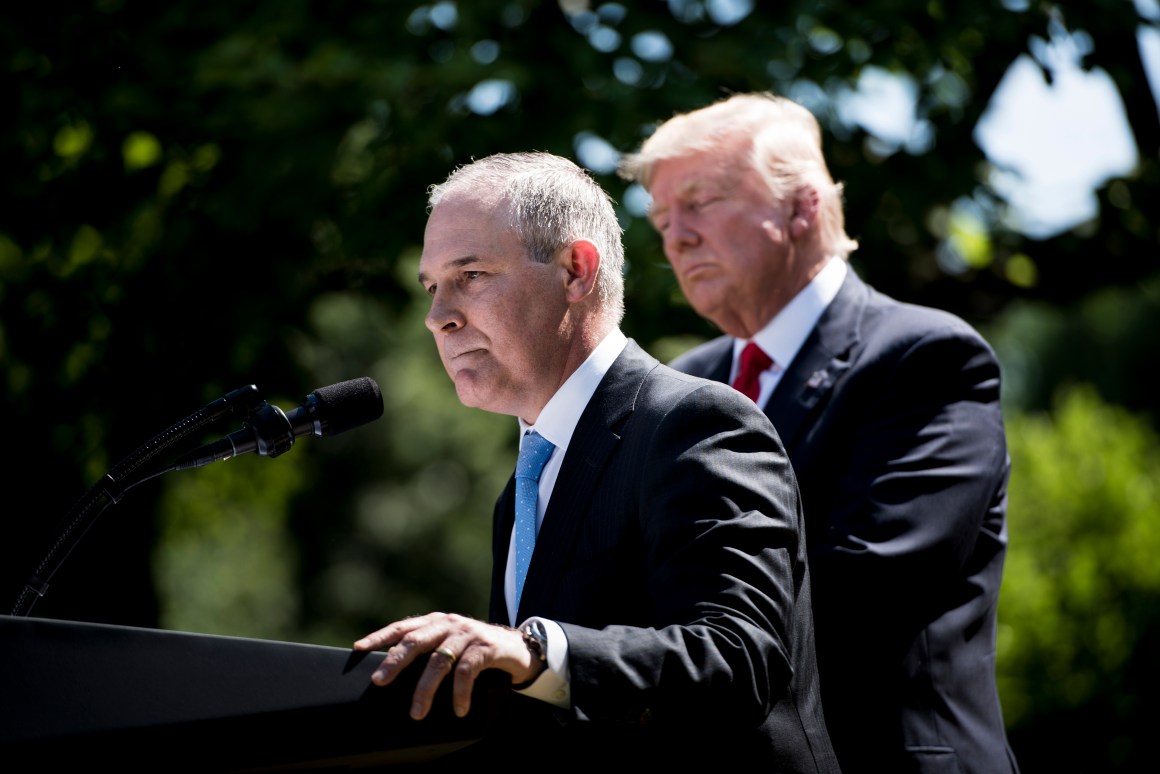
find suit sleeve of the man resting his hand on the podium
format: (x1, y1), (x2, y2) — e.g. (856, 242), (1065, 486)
(564, 376), (804, 724)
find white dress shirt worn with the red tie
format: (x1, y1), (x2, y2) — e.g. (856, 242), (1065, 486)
(728, 256), (849, 408)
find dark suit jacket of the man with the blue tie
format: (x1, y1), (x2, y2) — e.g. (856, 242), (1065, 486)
(466, 341), (838, 772)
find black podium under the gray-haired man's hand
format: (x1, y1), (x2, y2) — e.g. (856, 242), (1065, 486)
(0, 616), (509, 772)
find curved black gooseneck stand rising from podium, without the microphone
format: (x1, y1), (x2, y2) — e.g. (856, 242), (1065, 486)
(12, 384), (266, 616)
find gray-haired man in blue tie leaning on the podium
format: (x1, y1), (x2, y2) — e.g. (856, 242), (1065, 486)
(355, 153), (838, 772)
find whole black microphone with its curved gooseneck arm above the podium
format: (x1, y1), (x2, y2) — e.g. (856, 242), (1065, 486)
(12, 377), (383, 615)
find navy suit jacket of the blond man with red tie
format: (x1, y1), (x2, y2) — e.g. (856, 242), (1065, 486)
(673, 268), (1016, 774)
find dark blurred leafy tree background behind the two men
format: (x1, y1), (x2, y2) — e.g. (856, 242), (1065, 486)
(0, 0), (1160, 772)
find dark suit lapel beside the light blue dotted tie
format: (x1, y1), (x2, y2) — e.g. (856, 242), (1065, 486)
(517, 340), (659, 621)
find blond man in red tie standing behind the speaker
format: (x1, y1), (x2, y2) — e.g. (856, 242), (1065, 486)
(621, 94), (1017, 774)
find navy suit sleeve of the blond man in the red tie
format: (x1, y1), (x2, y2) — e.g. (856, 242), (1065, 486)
(799, 323), (1009, 665)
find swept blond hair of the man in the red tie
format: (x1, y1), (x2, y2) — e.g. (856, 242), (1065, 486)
(618, 92), (858, 258)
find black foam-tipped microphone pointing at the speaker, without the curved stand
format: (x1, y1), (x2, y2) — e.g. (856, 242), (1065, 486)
(171, 376), (383, 470)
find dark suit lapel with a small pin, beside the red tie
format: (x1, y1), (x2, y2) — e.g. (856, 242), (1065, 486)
(766, 268), (868, 454)
